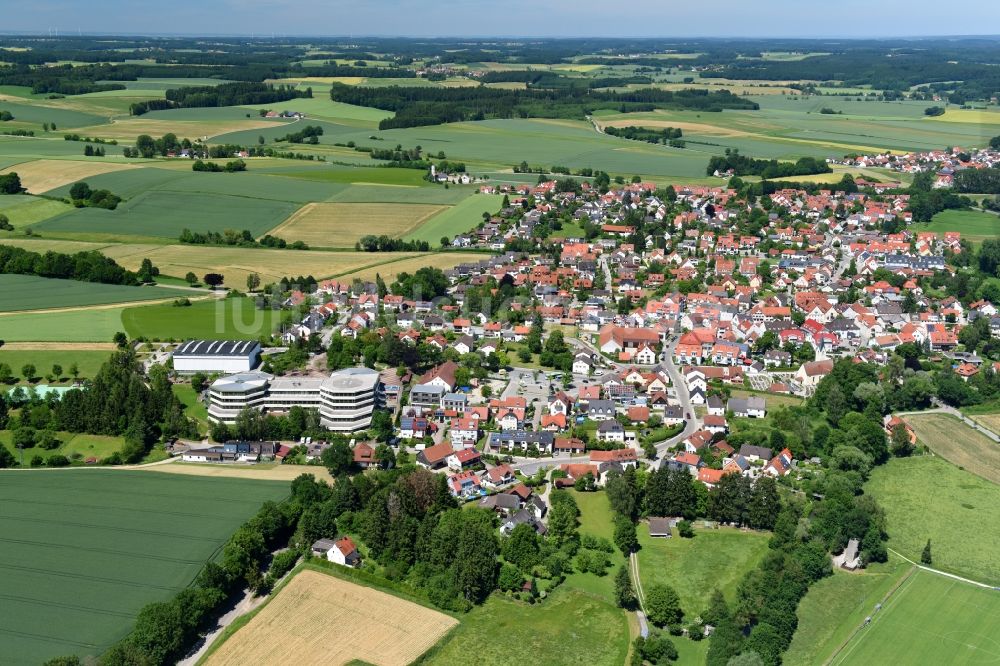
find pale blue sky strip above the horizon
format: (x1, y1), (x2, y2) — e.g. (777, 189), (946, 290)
(0, 0), (1000, 38)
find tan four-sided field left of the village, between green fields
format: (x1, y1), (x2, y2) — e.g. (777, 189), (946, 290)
(271, 203), (447, 247)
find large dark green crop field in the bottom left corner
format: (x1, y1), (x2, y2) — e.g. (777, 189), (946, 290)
(0, 469), (288, 664)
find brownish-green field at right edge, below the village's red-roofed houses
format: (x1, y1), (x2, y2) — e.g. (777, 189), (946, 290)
(905, 414), (1000, 483)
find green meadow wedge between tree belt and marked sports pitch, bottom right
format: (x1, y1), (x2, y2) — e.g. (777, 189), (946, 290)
(782, 556), (912, 666)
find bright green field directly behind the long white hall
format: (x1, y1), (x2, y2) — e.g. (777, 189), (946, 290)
(122, 298), (279, 340)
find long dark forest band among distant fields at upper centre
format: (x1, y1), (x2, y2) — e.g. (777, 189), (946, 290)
(330, 83), (759, 129)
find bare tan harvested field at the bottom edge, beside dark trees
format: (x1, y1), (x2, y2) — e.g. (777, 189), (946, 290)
(205, 569), (458, 666)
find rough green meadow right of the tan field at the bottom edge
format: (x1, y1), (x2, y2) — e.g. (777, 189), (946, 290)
(422, 590), (629, 666)
